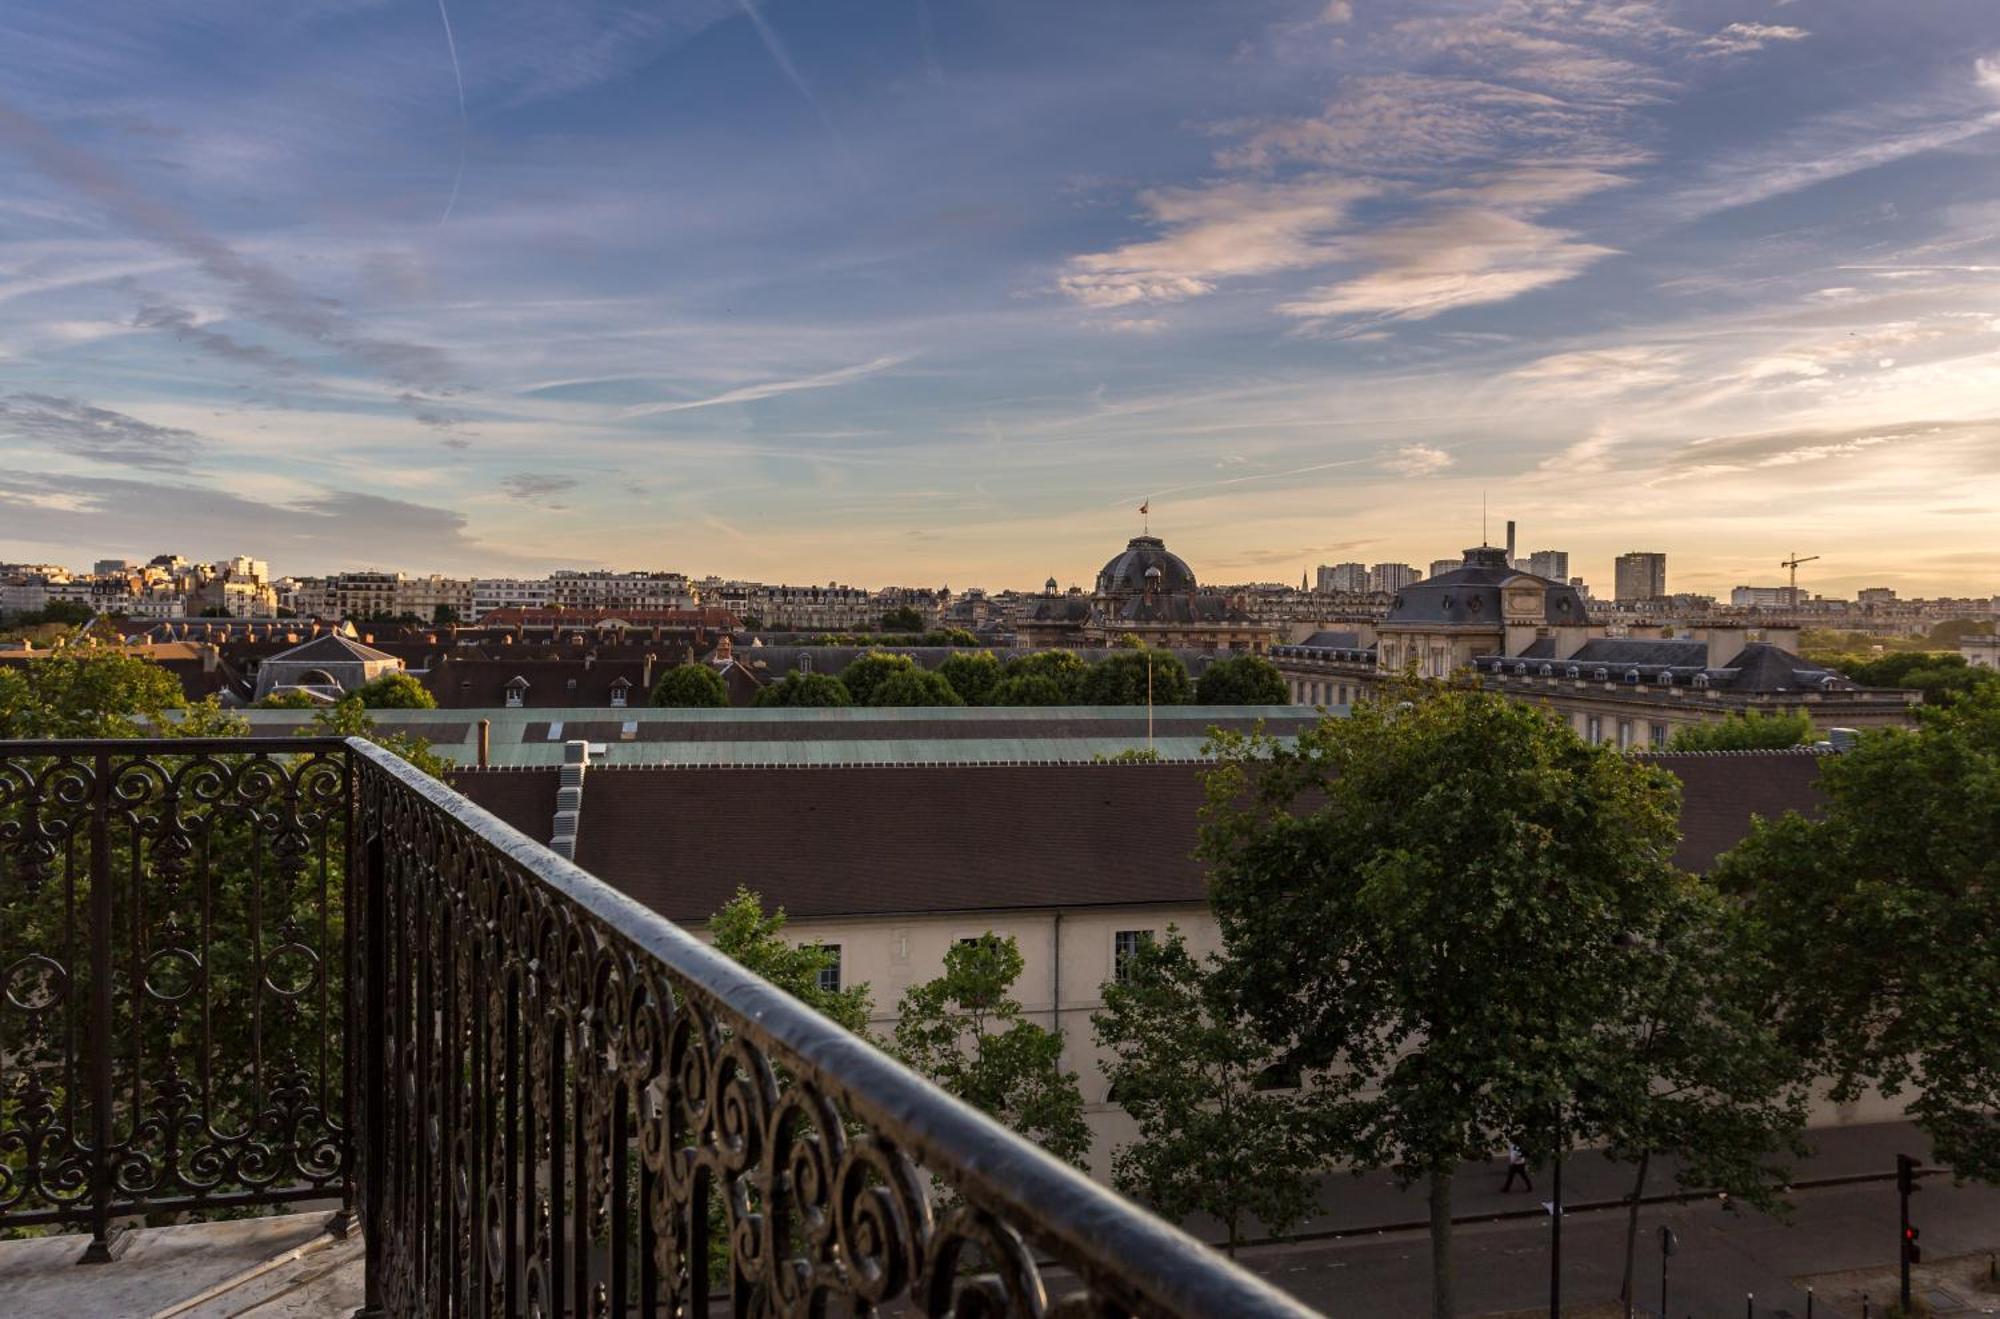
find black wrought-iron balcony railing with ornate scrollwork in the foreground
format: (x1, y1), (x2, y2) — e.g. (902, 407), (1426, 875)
(0, 737), (1310, 1317)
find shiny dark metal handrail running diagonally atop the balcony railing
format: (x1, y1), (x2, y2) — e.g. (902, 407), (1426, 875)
(348, 739), (1314, 1317)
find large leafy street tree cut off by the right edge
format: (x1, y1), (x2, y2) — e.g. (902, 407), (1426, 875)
(1716, 687), (2000, 1181)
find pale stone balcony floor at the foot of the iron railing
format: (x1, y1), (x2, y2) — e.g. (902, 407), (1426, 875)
(0, 1211), (362, 1319)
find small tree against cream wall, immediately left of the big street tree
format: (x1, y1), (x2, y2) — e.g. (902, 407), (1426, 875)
(1090, 927), (1320, 1257)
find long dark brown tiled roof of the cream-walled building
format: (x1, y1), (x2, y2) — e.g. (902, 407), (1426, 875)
(454, 751), (1818, 921)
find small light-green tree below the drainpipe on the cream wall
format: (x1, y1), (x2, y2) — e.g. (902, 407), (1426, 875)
(890, 933), (1090, 1163)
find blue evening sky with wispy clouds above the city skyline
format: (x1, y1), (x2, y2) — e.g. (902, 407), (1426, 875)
(0, 0), (2000, 596)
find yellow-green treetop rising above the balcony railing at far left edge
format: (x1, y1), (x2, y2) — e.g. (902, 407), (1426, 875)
(0, 646), (188, 737)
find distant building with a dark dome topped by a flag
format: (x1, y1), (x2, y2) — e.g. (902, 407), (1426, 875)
(1018, 536), (1276, 654)
